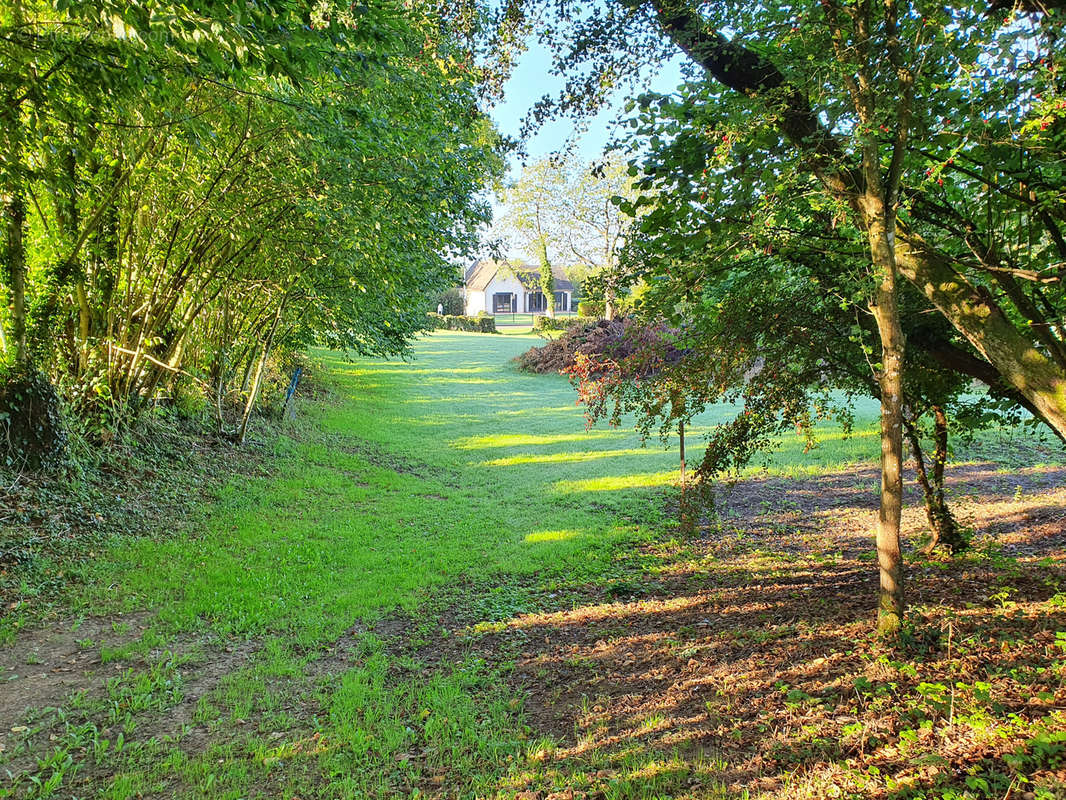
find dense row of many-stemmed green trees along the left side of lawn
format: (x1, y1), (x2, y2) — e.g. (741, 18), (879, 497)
(0, 0), (500, 454)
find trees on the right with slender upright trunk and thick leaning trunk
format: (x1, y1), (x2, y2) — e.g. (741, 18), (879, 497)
(496, 0), (1066, 631)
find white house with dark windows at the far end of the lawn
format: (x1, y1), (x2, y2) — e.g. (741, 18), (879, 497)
(466, 259), (574, 317)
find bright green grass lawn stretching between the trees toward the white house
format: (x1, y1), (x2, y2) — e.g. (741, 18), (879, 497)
(0, 332), (1066, 798)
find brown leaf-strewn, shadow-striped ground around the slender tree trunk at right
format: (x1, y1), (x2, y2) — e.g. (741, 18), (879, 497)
(422, 465), (1066, 799)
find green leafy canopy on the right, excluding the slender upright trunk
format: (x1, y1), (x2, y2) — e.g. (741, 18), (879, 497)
(516, 0), (1066, 445)
